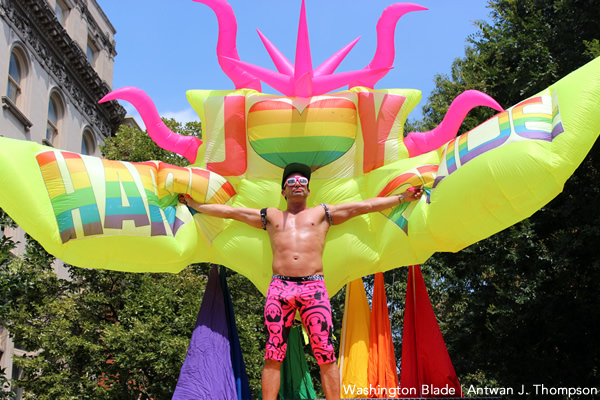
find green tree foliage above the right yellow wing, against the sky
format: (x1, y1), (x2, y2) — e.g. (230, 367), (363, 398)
(412, 0), (600, 133)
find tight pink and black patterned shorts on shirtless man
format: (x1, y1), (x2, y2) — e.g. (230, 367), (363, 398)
(265, 275), (335, 365)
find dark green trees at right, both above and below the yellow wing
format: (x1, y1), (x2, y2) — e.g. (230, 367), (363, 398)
(411, 0), (600, 396)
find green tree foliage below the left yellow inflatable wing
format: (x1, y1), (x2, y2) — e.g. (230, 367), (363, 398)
(4, 250), (206, 399)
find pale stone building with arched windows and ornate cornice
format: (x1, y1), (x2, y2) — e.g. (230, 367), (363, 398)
(0, 0), (125, 398)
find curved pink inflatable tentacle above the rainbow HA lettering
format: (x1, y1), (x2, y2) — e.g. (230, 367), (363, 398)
(98, 86), (202, 164)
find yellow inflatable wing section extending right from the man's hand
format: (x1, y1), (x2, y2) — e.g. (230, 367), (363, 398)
(409, 58), (600, 252)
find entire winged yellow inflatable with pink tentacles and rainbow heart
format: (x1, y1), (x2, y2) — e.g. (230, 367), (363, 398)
(0, 0), (600, 293)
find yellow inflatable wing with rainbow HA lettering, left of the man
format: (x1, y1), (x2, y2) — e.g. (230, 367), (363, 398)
(0, 138), (235, 272)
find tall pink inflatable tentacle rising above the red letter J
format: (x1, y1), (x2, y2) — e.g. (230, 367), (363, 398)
(194, 0), (261, 92)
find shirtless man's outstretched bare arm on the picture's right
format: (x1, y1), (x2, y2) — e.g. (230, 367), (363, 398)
(329, 187), (423, 225)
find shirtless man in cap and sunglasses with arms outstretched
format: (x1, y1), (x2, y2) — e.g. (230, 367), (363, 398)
(179, 163), (423, 400)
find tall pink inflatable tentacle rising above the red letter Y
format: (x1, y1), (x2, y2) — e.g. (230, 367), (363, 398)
(350, 3), (427, 89)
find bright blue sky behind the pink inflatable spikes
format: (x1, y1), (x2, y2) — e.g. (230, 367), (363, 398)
(97, 0), (490, 127)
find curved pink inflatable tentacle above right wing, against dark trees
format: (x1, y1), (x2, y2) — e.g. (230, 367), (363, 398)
(404, 90), (504, 157)
